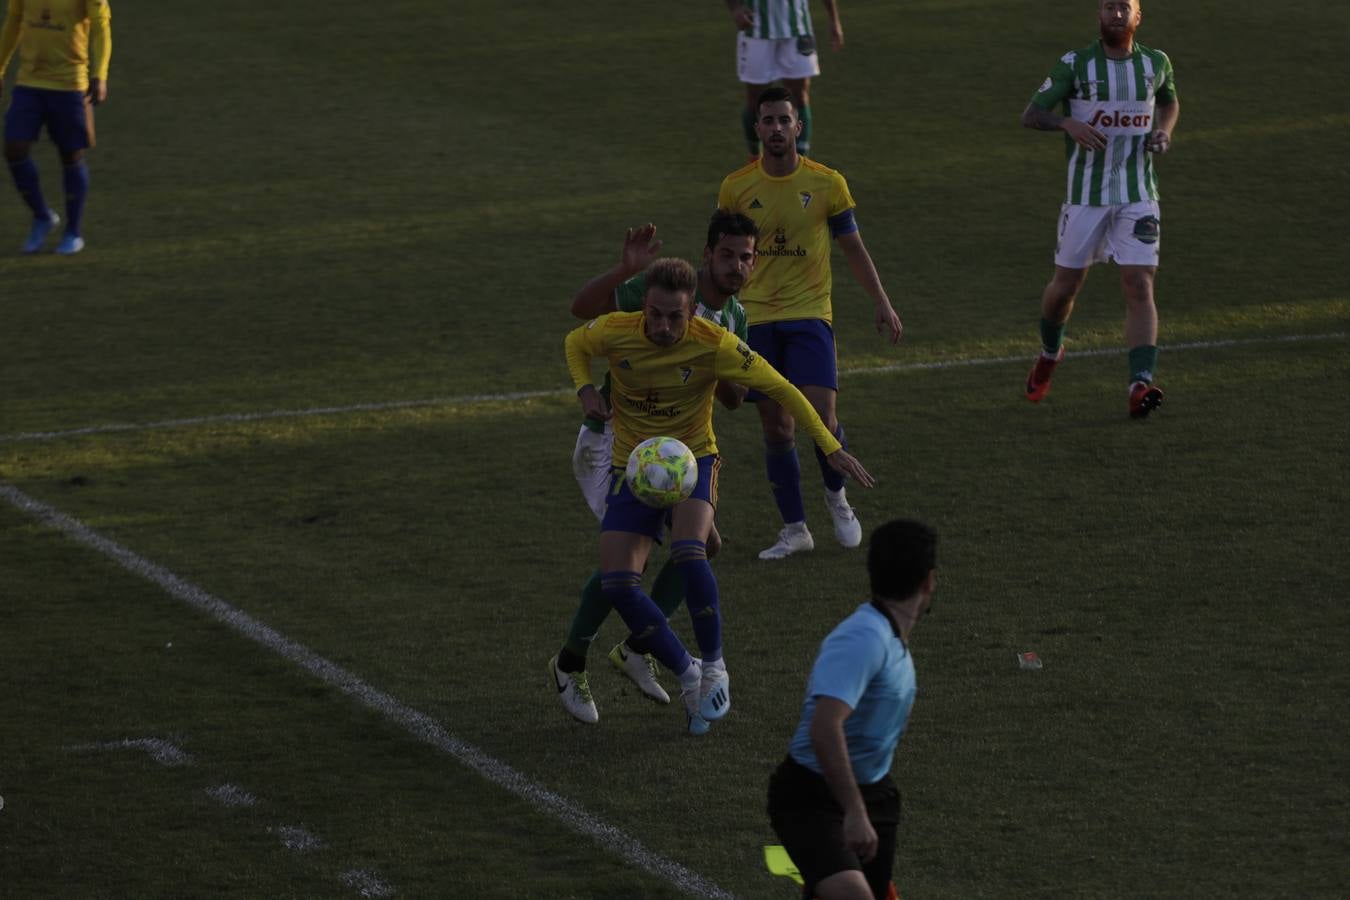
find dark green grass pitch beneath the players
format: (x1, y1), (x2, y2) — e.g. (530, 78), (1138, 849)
(0, 0), (1350, 900)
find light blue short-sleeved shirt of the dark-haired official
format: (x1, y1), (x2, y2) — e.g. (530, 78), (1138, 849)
(788, 603), (917, 784)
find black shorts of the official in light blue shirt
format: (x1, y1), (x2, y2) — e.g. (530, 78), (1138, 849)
(768, 757), (900, 900)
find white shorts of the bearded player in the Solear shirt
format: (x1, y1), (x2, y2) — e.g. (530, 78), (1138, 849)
(1054, 200), (1162, 269)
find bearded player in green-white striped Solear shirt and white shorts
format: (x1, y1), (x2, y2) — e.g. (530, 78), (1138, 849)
(1022, 0), (1181, 418)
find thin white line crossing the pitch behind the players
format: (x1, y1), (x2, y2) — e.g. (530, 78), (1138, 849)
(0, 332), (1350, 444)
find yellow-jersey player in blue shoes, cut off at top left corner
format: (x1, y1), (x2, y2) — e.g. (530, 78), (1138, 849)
(0, 0), (112, 255)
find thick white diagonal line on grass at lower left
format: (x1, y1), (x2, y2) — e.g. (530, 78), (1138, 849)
(0, 484), (733, 899)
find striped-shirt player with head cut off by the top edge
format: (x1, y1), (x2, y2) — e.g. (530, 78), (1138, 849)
(726, 0), (844, 159)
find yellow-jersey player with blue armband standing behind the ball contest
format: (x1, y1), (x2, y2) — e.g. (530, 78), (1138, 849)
(717, 88), (902, 560)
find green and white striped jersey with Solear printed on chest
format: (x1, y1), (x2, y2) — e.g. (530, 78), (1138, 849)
(1031, 40), (1177, 206)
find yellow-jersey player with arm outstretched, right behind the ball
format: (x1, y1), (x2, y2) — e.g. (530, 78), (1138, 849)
(566, 259), (872, 734)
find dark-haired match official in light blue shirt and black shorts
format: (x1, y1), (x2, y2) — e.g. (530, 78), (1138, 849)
(768, 519), (937, 900)
